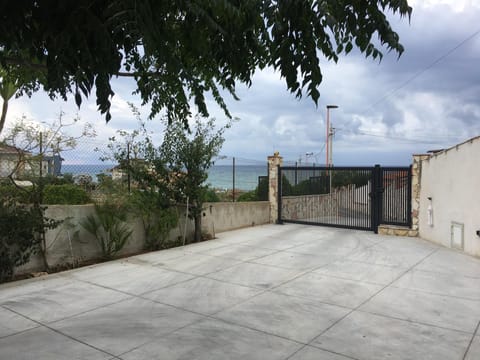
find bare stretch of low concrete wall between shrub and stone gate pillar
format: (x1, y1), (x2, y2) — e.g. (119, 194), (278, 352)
(202, 201), (270, 236)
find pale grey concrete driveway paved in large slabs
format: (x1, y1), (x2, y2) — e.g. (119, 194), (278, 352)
(0, 224), (480, 360)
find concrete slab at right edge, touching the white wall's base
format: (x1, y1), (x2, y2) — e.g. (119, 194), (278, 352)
(416, 249), (480, 278)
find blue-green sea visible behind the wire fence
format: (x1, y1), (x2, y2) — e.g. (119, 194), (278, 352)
(61, 163), (268, 191)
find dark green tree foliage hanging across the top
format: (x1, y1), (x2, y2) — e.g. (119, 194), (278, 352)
(0, 0), (412, 125)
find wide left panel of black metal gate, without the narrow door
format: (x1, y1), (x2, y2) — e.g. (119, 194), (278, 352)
(278, 167), (373, 230)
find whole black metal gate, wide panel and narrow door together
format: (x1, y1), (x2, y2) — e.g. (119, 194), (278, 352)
(278, 165), (412, 232)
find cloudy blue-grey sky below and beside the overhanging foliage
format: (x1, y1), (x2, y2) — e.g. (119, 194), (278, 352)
(3, 0), (480, 166)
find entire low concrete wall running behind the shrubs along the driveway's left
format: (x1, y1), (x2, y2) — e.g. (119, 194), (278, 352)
(16, 201), (270, 274)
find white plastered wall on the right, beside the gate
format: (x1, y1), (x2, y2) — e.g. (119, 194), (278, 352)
(418, 137), (480, 256)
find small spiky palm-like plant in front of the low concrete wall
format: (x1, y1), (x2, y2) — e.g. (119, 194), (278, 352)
(80, 202), (133, 260)
